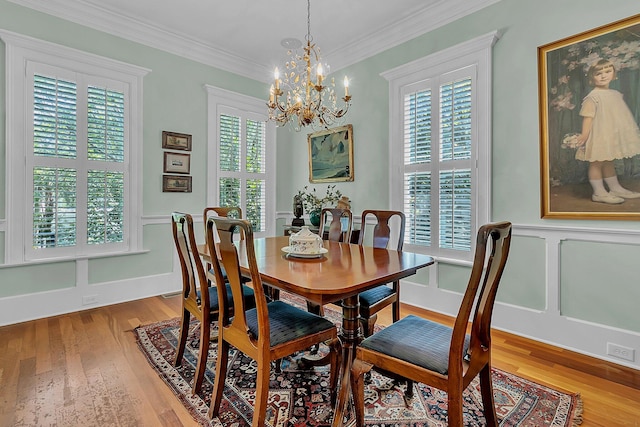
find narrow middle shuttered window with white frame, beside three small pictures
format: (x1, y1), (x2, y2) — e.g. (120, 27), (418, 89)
(207, 87), (275, 236)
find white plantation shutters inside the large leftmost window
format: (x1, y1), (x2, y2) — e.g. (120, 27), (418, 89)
(30, 69), (126, 253)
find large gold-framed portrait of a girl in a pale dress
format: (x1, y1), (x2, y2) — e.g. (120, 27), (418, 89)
(538, 15), (640, 220)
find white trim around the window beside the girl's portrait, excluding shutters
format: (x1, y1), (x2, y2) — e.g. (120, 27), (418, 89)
(380, 31), (499, 263)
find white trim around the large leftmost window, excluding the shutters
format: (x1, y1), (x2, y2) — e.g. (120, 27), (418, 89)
(0, 30), (151, 264)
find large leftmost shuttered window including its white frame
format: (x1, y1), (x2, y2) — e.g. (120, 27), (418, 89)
(0, 31), (147, 263)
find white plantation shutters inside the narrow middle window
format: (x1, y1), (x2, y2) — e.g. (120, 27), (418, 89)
(218, 113), (267, 232)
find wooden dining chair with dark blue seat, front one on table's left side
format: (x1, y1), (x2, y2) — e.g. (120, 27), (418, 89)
(207, 217), (342, 427)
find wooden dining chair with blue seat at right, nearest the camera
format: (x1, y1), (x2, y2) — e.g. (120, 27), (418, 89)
(351, 222), (511, 427)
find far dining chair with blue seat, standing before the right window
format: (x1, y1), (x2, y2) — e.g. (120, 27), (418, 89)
(358, 209), (406, 337)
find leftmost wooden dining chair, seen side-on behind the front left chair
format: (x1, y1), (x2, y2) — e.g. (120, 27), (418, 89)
(171, 212), (255, 394)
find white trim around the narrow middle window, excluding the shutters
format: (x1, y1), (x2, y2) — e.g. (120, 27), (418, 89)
(204, 85), (276, 237)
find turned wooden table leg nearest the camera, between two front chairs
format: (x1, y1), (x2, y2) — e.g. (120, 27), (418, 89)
(332, 295), (360, 427)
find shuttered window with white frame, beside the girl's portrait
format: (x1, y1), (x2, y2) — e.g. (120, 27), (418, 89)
(384, 30), (495, 261)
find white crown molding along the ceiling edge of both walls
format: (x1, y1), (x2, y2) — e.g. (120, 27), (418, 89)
(9, 0), (500, 83)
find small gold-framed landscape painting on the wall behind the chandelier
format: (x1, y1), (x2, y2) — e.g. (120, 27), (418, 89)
(307, 125), (354, 182)
